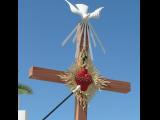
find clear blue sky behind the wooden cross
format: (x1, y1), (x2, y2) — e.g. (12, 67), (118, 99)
(18, 0), (140, 120)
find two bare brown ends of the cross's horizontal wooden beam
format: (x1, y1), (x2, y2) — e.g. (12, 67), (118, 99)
(29, 67), (130, 93)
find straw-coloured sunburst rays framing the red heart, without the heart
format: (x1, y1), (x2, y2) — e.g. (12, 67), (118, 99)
(59, 50), (109, 110)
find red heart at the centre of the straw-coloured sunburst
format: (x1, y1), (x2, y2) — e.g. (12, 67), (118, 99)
(75, 68), (92, 91)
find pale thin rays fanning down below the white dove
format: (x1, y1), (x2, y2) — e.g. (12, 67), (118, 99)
(62, 21), (106, 60)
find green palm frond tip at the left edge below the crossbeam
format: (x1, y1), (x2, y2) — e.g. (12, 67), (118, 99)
(18, 83), (32, 94)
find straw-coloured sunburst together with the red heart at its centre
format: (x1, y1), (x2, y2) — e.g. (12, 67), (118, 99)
(59, 50), (110, 110)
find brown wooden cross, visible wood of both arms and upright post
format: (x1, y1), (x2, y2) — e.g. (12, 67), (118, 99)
(29, 23), (130, 120)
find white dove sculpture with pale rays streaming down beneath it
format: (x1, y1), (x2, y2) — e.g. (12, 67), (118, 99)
(62, 0), (105, 60)
